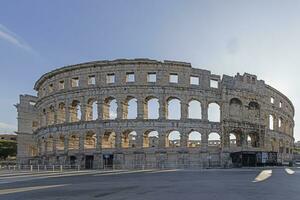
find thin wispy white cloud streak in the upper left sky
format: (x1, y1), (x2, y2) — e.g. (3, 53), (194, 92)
(0, 24), (34, 52)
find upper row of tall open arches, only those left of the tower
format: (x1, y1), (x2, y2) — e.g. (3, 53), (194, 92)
(41, 96), (220, 126)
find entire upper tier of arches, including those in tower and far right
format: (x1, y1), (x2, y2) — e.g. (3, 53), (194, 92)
(40, 96), (293, 137)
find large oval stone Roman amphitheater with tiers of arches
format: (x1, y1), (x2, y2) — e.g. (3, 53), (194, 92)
(16, 59), (294, 168)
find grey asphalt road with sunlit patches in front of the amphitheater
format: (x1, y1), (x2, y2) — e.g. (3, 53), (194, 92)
(0, 168), (300, 200)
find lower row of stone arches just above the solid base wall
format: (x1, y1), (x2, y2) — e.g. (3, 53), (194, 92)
(39, 130), (258, 152)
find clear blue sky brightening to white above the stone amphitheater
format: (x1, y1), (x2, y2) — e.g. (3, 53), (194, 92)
(0, 0), (300, 140)
